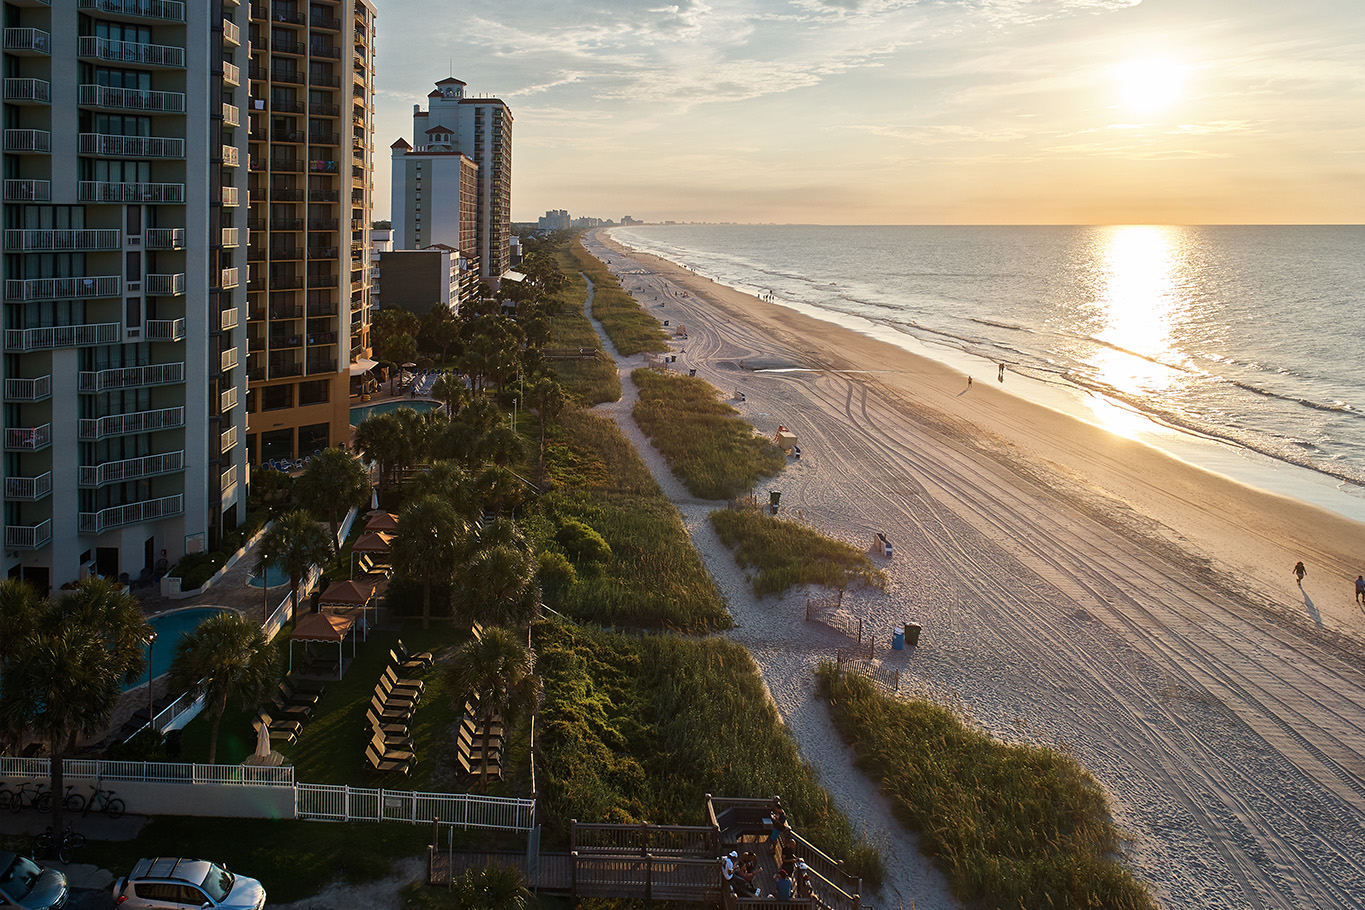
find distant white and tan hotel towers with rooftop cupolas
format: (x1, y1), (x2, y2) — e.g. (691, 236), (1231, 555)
(392, 78), (512, 288)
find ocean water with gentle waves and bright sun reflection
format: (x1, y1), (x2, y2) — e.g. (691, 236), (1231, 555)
(612, 225), (1365, 520)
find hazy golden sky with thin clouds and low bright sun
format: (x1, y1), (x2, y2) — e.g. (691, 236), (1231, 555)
(375, 0), (1365, 224)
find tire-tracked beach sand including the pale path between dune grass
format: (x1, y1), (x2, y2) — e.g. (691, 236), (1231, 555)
(587, 232), (1365, 910)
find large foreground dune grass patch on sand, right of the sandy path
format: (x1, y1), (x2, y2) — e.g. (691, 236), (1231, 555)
(818, 663), (1156, 910)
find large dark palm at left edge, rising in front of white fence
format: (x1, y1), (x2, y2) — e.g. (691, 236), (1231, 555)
(0, 578), (150, 831)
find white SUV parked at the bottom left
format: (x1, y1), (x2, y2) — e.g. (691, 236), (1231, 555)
(113, 857), (265, 910)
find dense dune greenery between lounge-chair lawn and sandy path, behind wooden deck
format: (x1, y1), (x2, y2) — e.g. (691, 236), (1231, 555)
(535, 621), (883, 890)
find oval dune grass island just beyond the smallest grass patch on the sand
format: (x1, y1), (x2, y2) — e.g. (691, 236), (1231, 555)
(631, 368), (786, 499)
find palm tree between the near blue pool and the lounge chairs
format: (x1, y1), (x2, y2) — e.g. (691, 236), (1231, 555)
(169, 611), (280, 764)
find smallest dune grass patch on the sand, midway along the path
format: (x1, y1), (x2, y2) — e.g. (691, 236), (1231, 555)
(711, 509), (886, 598)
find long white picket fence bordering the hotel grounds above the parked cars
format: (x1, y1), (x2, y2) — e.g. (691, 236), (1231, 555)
(0, 756), (535, 831)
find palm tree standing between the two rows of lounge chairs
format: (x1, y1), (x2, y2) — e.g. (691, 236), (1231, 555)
(441, 626), (536, 772)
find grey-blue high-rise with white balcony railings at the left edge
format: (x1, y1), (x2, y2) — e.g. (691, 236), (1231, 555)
(0, 0), (248, 591)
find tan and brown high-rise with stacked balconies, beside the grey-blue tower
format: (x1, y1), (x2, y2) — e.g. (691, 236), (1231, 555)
(242, 0), (375, 464)
